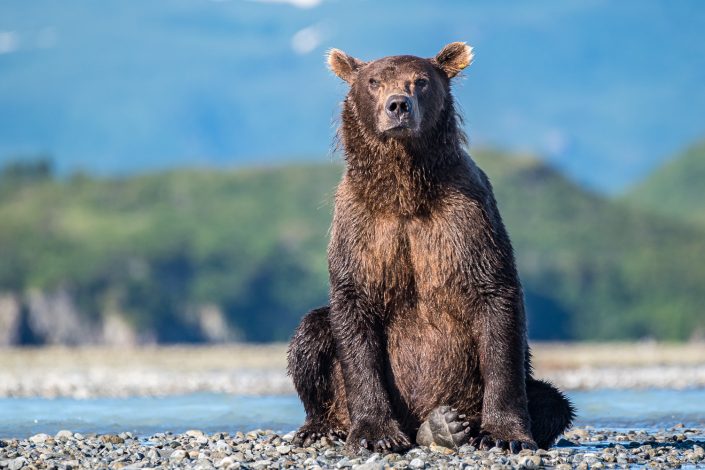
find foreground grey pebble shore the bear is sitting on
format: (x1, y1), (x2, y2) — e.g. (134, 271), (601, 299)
(0, 426), (705, 470)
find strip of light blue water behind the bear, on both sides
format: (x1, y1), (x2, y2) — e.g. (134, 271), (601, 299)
(0, 389), (705, 438)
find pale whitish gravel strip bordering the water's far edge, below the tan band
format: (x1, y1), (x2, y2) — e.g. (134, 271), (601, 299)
(0, 365), (705, 399)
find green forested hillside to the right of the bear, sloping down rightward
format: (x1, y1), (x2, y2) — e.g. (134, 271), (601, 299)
(477, 155), (705, 339)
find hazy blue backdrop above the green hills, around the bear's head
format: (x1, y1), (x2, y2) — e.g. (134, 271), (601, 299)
(0, 0), (705, 191)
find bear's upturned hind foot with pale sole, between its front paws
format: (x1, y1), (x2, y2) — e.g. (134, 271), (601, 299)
(416, 406), (481, 449)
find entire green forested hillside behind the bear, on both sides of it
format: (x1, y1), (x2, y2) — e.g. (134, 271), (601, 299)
(0, 152), (705, 342)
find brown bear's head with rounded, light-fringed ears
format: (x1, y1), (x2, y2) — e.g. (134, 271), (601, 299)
(328, 42), (473, 140)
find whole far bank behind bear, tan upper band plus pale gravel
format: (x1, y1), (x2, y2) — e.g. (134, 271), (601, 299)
(0, 343), (705, 398)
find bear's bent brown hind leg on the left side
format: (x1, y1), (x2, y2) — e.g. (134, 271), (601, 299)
(287, 306), (346, 446)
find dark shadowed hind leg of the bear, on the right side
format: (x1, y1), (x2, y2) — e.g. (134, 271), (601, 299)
(526, 379), (575, 449)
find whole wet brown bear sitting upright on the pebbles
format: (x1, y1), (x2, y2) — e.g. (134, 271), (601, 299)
(288, 43), (574, 452)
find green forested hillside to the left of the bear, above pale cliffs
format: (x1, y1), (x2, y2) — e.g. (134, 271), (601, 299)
(0, 165), (340, 341)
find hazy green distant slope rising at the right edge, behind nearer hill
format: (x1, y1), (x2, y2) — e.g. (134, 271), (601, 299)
(625, 140), (705, 226)
